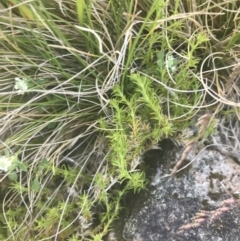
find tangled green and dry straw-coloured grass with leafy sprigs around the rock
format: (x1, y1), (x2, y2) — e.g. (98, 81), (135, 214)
(0, 0), (240, 241)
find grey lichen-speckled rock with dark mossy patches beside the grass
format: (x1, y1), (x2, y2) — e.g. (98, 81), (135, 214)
(123, 141), (240, 241)
